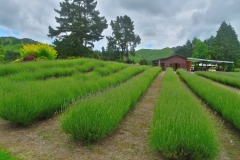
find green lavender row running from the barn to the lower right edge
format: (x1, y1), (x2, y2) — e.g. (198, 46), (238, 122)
(178, 70), (240, 129)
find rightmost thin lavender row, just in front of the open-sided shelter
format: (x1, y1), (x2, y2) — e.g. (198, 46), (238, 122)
(195, 72), (240, 88)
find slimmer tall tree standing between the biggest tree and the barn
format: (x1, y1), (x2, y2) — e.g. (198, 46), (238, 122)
(107, 15), (141, 62)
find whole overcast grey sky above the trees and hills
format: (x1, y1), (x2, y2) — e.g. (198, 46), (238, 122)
(0, 0), (240, 49)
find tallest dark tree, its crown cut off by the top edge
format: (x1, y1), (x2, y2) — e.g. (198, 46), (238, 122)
(48, 0), (107, 57)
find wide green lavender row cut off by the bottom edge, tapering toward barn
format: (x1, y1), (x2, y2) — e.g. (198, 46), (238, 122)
(150, 68), (218, 159)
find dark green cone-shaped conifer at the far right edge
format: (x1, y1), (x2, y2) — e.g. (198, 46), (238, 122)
(210, 22), (240, 62)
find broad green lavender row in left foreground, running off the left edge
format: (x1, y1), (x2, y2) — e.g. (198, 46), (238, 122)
(0, 65), (147, 125)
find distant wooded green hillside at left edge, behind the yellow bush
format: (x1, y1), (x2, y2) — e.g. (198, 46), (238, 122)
(0, 37), (37, 52)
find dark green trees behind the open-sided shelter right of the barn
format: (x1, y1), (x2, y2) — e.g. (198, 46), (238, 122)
(173, 21), (240, 67)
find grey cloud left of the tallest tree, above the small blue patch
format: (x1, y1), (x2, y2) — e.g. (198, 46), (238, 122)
(0, 0), (59, 42)
